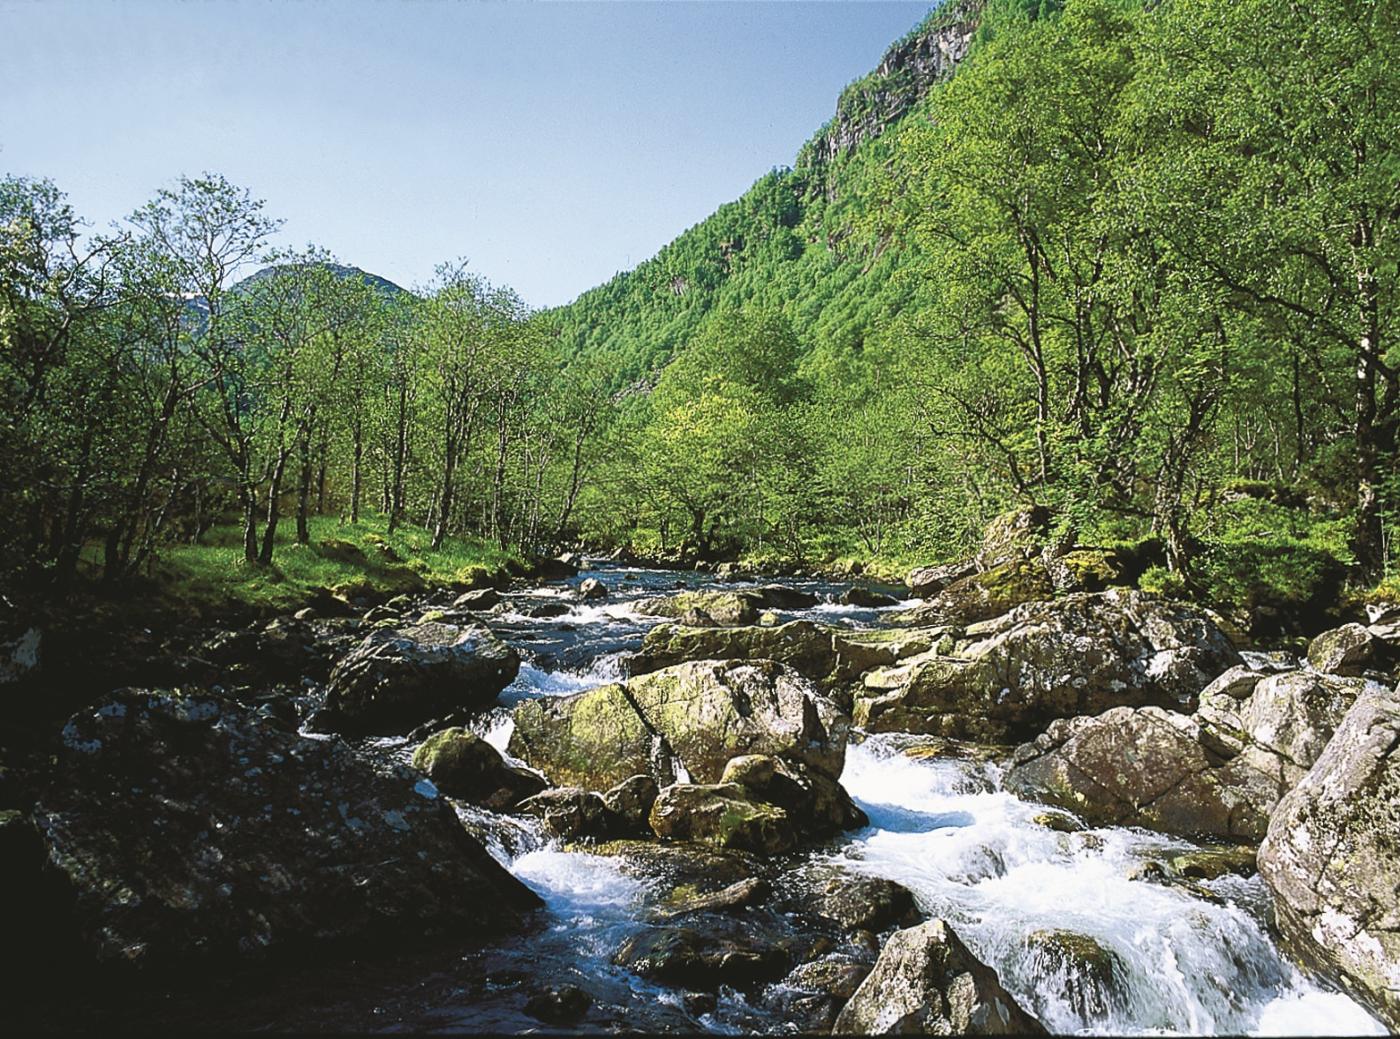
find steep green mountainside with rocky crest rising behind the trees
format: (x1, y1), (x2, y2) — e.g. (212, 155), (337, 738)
(553, 0), (984, 382)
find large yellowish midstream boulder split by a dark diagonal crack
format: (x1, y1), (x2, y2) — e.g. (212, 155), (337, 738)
(510, 660), (847, 791)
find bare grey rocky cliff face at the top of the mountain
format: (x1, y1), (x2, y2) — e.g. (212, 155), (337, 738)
(798, 0), (986, 167)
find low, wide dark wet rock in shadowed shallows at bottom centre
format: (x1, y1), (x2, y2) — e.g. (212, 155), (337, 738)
(613, 926), (792, 989)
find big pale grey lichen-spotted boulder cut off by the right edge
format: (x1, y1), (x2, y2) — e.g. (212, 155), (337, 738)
(1259, 686), (1400, 1031)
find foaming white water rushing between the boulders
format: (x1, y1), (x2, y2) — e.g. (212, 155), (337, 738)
(464, 571), (1385, 1035)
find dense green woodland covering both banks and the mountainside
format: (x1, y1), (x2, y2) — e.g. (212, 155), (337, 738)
(0, 0), (1400, 630)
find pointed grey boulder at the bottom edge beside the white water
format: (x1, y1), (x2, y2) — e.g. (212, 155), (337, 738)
(834, 920), (1044, 1035)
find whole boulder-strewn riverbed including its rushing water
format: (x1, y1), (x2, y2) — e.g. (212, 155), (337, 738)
(3, 560), (1400, 1035)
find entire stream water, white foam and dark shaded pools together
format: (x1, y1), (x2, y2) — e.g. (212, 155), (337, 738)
(43, 566), (1385, 1035)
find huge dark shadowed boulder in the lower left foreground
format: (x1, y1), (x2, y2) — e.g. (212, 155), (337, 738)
(34, 690), (539, 969)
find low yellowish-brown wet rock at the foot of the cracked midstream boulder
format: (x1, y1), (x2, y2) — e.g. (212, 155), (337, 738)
(651, 783), (797, 856)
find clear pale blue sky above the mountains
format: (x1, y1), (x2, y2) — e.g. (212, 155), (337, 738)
(0, 0), (931, 307)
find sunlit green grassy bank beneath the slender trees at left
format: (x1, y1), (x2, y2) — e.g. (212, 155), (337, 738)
(153, 515), (521, 613)
